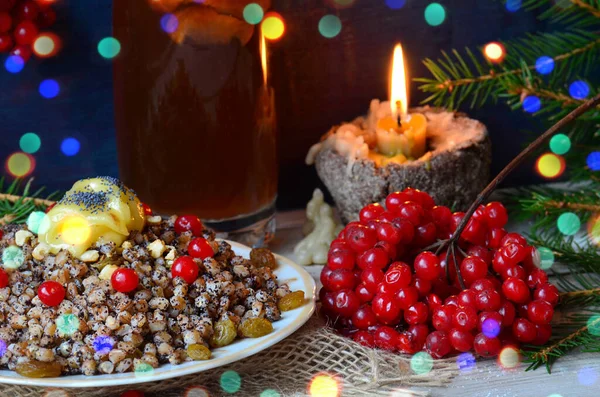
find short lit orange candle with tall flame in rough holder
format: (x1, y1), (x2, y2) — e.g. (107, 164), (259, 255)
(376, 44), (427, 162)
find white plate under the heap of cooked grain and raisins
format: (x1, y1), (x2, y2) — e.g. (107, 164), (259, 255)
(0, 241), (316, 387)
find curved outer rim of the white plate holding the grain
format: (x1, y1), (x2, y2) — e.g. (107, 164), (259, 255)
(0, 239), (317, 389)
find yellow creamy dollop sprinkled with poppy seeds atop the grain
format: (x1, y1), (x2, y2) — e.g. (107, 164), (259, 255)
(39, 177), (145, 258)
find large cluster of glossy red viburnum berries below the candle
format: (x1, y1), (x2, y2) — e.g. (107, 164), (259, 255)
(320, 188), (559, 358)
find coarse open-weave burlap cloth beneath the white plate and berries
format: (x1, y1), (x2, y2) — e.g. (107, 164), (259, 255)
(0, 316), (458, 397)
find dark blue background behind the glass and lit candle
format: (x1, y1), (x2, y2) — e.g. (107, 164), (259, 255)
(0, 0), (547, 209)
